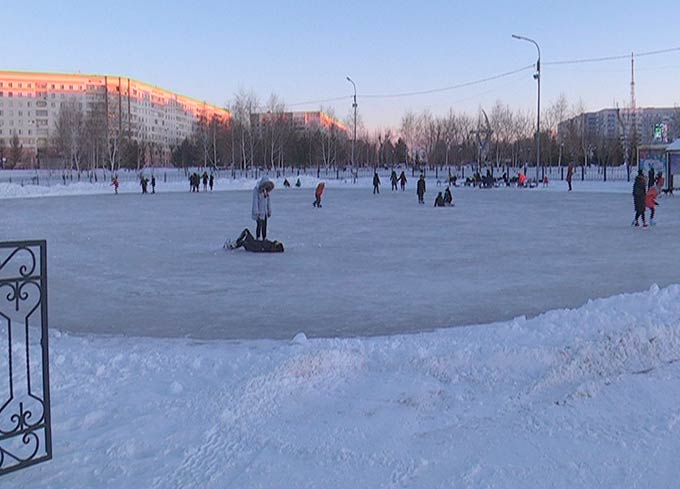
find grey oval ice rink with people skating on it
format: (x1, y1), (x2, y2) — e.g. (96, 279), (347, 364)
(0, 182), (680, 339)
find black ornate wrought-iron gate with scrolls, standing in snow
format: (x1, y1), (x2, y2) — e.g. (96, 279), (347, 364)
(0, 241), (52, 475)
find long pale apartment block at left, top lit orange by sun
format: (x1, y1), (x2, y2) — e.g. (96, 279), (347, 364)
(0, 71), (230, 164)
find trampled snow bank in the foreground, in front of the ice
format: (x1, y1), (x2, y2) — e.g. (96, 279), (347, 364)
(1, 284), (680, 489)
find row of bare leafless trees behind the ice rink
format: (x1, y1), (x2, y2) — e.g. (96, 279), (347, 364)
(18, 86), (680, 171)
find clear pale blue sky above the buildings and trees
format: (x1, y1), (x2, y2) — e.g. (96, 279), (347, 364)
(0, 0), (680, 131)
